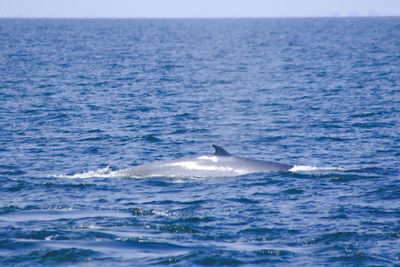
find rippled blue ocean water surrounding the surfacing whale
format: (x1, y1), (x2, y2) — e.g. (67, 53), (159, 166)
(0, 17), (400, 266)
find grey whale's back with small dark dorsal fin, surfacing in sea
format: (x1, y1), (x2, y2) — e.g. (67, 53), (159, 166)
(118, 145), (294, 178)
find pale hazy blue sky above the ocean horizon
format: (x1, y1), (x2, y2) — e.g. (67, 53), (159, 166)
(0, 0), (400, 18)
